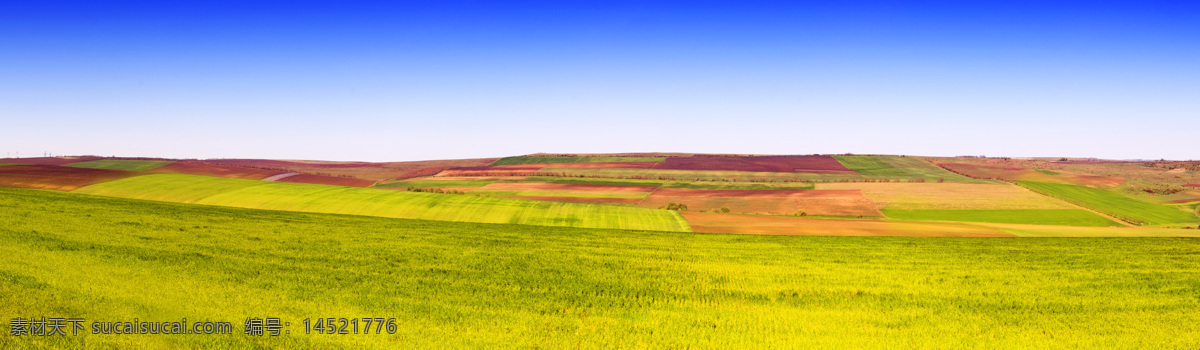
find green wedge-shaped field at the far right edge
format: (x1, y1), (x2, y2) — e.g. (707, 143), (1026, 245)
(1018, 181), (1200, 225)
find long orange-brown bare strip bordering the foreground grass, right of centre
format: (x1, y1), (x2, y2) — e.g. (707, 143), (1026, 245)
(682, 212), (1013, 237)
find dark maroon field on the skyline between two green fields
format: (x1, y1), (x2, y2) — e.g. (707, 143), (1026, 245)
(654, 156), (856, 174)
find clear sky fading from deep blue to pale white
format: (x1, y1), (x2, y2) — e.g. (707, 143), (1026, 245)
(0, 0), (1200, 161)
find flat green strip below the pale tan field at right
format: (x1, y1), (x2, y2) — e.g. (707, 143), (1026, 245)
(883, 209), (1121, 227)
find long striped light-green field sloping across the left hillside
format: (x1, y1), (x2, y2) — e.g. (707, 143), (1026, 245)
(76, 174), (689, 231)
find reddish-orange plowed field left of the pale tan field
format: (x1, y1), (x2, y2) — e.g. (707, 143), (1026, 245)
(637, 188), (882, 216)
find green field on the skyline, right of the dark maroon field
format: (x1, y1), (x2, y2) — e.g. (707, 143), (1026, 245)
(833, 156), (992, 183)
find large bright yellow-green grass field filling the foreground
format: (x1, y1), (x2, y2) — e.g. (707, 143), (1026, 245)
(0, 188), (1200, 349)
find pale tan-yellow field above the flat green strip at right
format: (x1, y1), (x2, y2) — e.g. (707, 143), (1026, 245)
(816, 182), (1076, 210)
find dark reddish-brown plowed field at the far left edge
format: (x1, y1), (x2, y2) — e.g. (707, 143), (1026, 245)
(0, 165), (138, 191)
